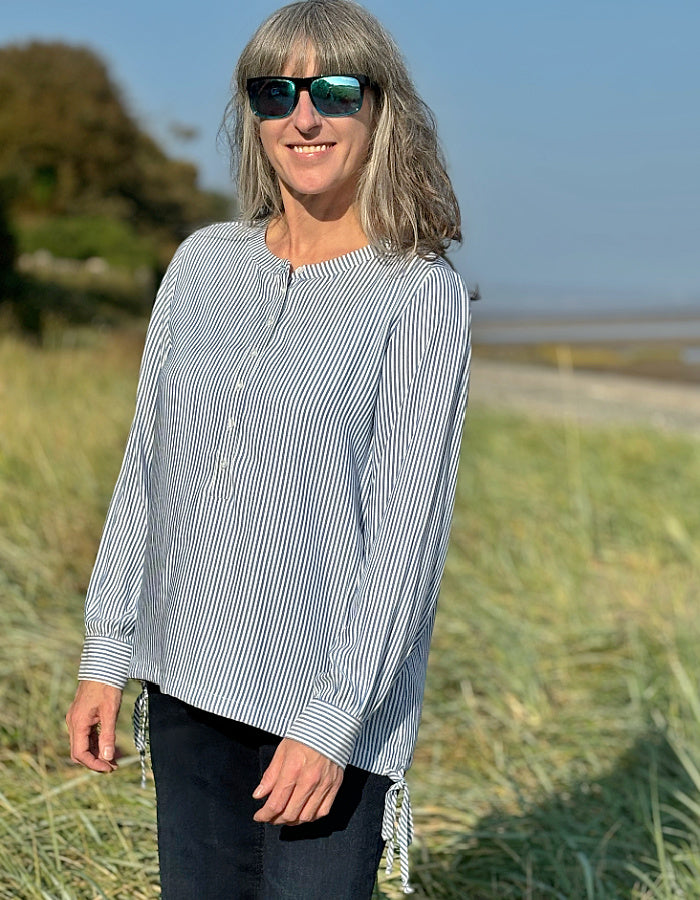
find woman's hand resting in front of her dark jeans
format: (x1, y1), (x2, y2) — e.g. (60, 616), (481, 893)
(253, 738), (343, 825)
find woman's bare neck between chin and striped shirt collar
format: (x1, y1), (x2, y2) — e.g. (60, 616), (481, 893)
(266, 186), (368, 269)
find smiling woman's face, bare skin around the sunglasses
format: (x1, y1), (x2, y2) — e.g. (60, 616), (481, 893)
(260, 58), (374, 214)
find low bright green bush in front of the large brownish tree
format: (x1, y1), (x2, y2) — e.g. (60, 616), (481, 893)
(19, 216), (158, 269)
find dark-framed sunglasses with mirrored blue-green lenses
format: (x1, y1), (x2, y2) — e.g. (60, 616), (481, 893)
(246, 75), (371, 119)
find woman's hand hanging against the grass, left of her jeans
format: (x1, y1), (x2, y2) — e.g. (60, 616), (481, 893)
(66, 681), (122, 772)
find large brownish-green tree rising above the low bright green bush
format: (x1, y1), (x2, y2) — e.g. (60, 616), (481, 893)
(0, 42), (230, 239)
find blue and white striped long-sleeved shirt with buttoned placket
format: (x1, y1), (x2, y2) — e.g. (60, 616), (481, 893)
(80, 223), (470, 892)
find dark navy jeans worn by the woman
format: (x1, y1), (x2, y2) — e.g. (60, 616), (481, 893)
(149, 686), (391, 900)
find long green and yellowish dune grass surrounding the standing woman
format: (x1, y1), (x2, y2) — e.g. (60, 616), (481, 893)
(0, 331), (700, 900)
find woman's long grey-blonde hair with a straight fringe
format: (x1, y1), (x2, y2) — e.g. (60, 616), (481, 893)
(222, 0), (462, 257)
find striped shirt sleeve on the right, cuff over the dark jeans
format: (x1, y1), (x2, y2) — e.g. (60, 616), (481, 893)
(287, 266), (470, 765)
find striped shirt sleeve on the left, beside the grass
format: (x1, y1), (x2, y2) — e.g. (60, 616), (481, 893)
(78, 246), (179, 688)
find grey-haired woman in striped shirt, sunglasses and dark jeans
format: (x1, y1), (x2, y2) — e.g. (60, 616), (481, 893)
(67, 0), (469, 900)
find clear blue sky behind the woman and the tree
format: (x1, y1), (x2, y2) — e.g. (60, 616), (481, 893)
(0, 0), (700, 315)
